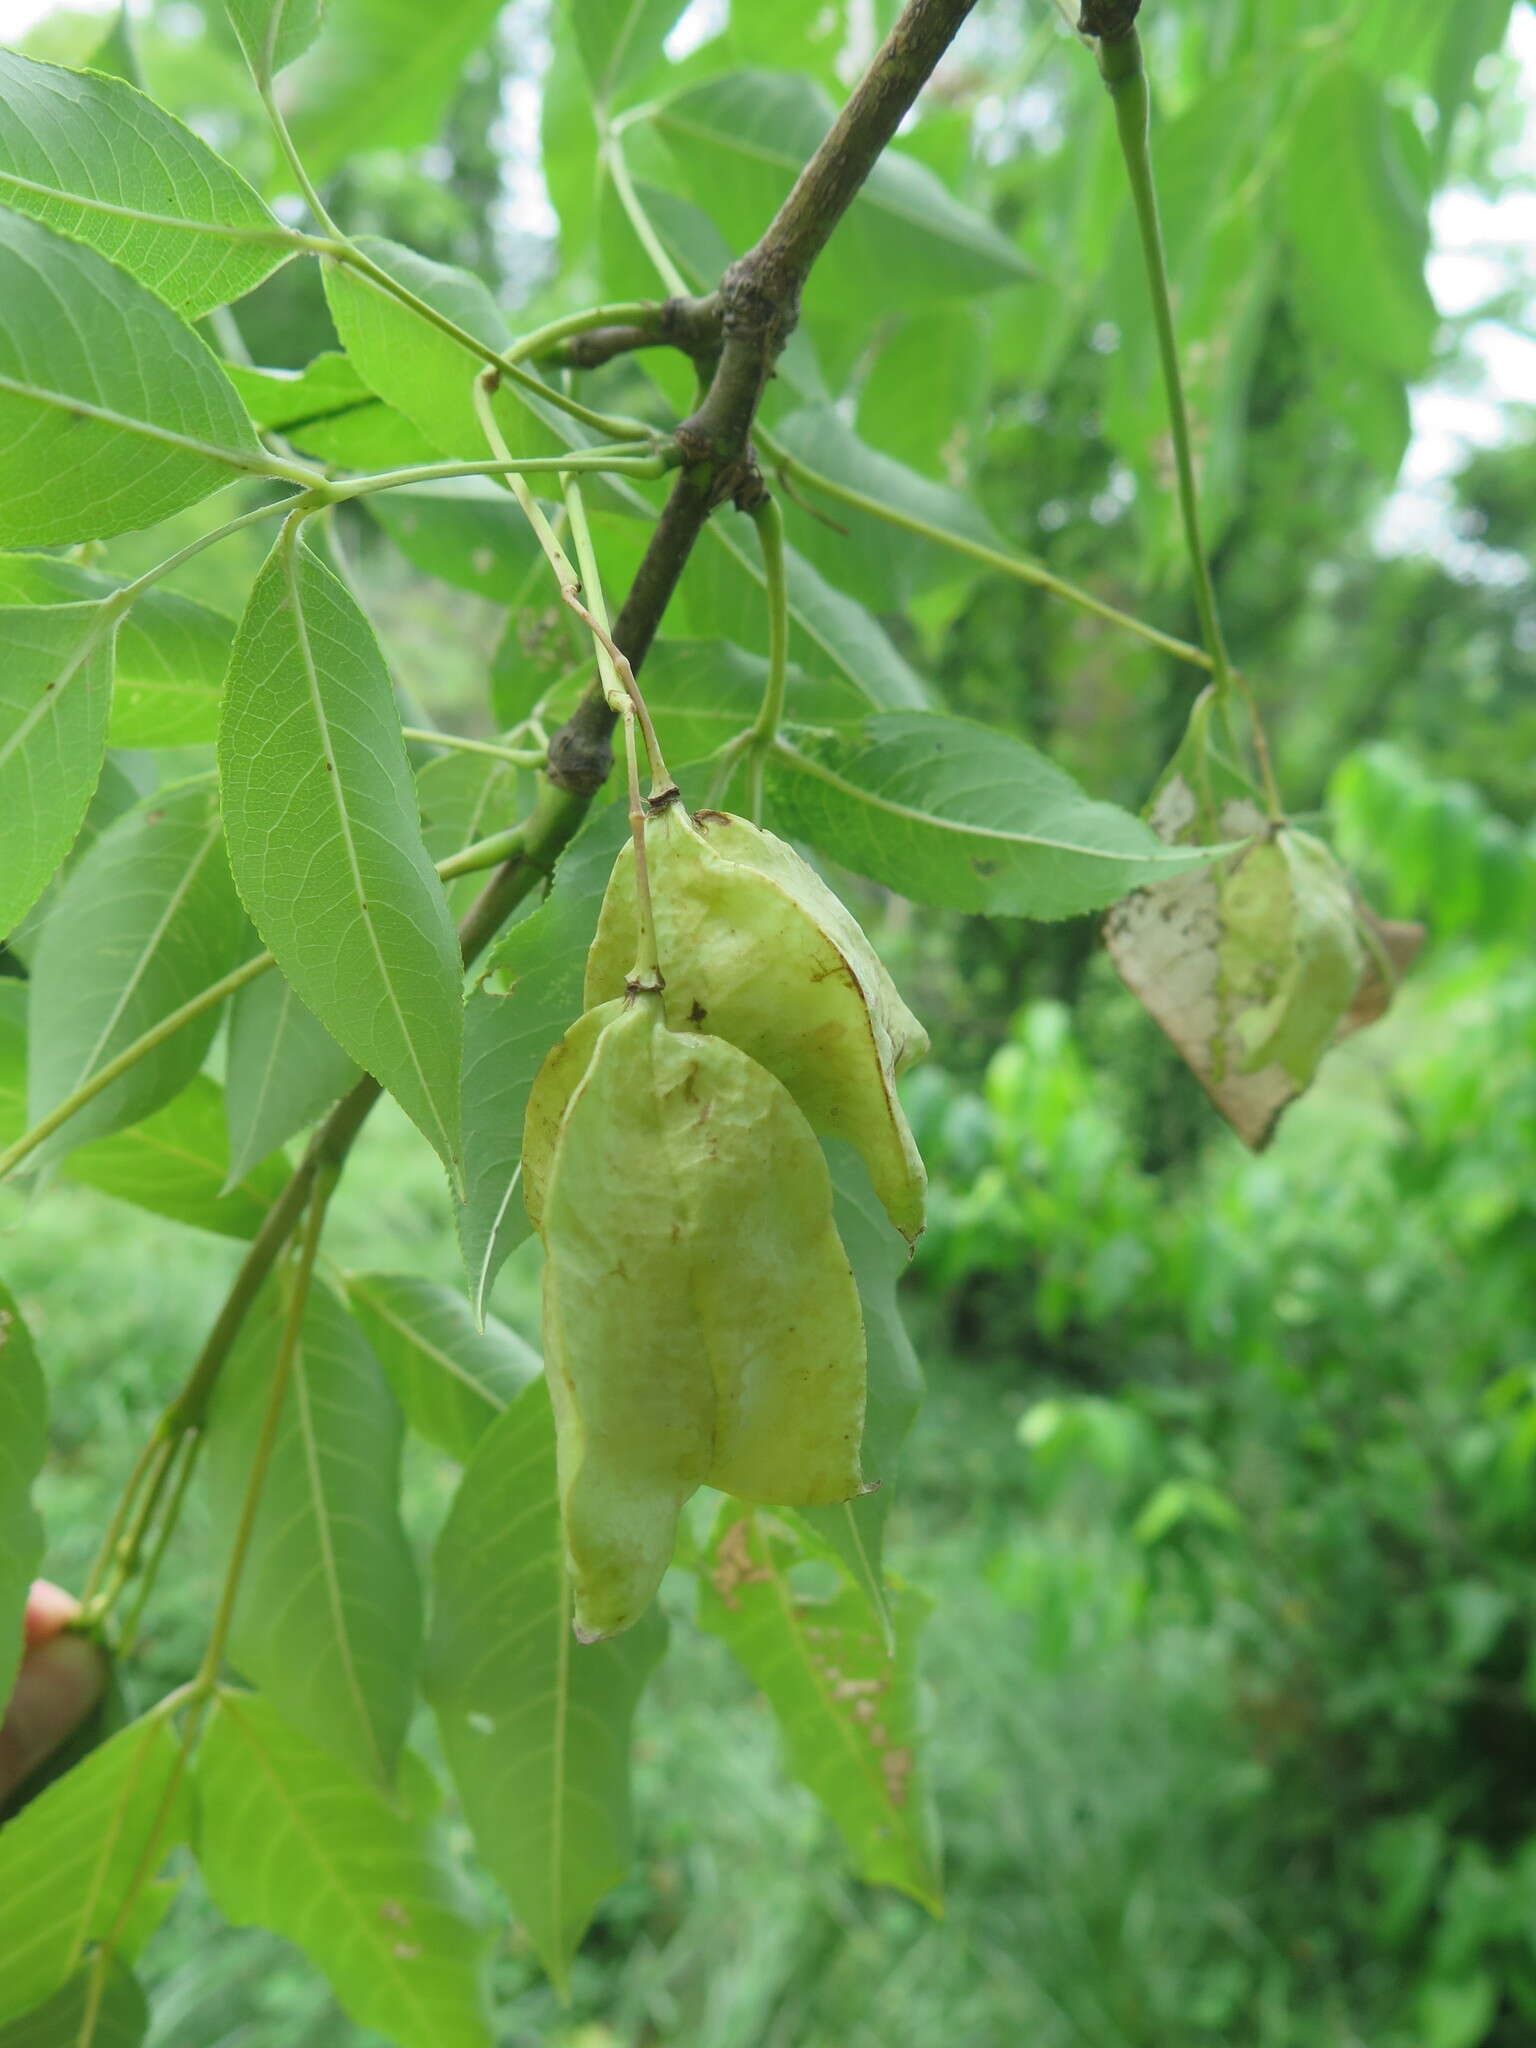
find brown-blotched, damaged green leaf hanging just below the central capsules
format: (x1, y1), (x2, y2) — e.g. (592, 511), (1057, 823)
(698, 1501), (942, 1913)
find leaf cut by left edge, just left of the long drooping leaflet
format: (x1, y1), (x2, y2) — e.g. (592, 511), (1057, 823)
(0, 604), (115, 932)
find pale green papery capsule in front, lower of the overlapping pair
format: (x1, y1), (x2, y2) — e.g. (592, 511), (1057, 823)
(539, 995), (864, 1640)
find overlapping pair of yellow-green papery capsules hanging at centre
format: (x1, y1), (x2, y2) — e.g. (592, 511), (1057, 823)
(522, 788), (928, 1640)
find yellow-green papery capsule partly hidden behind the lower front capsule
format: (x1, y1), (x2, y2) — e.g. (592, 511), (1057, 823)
(586, 803), (928, 1241)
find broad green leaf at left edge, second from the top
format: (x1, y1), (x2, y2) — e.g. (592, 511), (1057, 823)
(0, 211), (268, 547)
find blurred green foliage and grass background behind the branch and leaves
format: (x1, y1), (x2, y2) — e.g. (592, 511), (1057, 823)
(0, 0), (1536, 2048)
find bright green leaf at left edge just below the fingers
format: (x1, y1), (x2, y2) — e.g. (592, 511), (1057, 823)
(0, 1720), (188, 2019)
